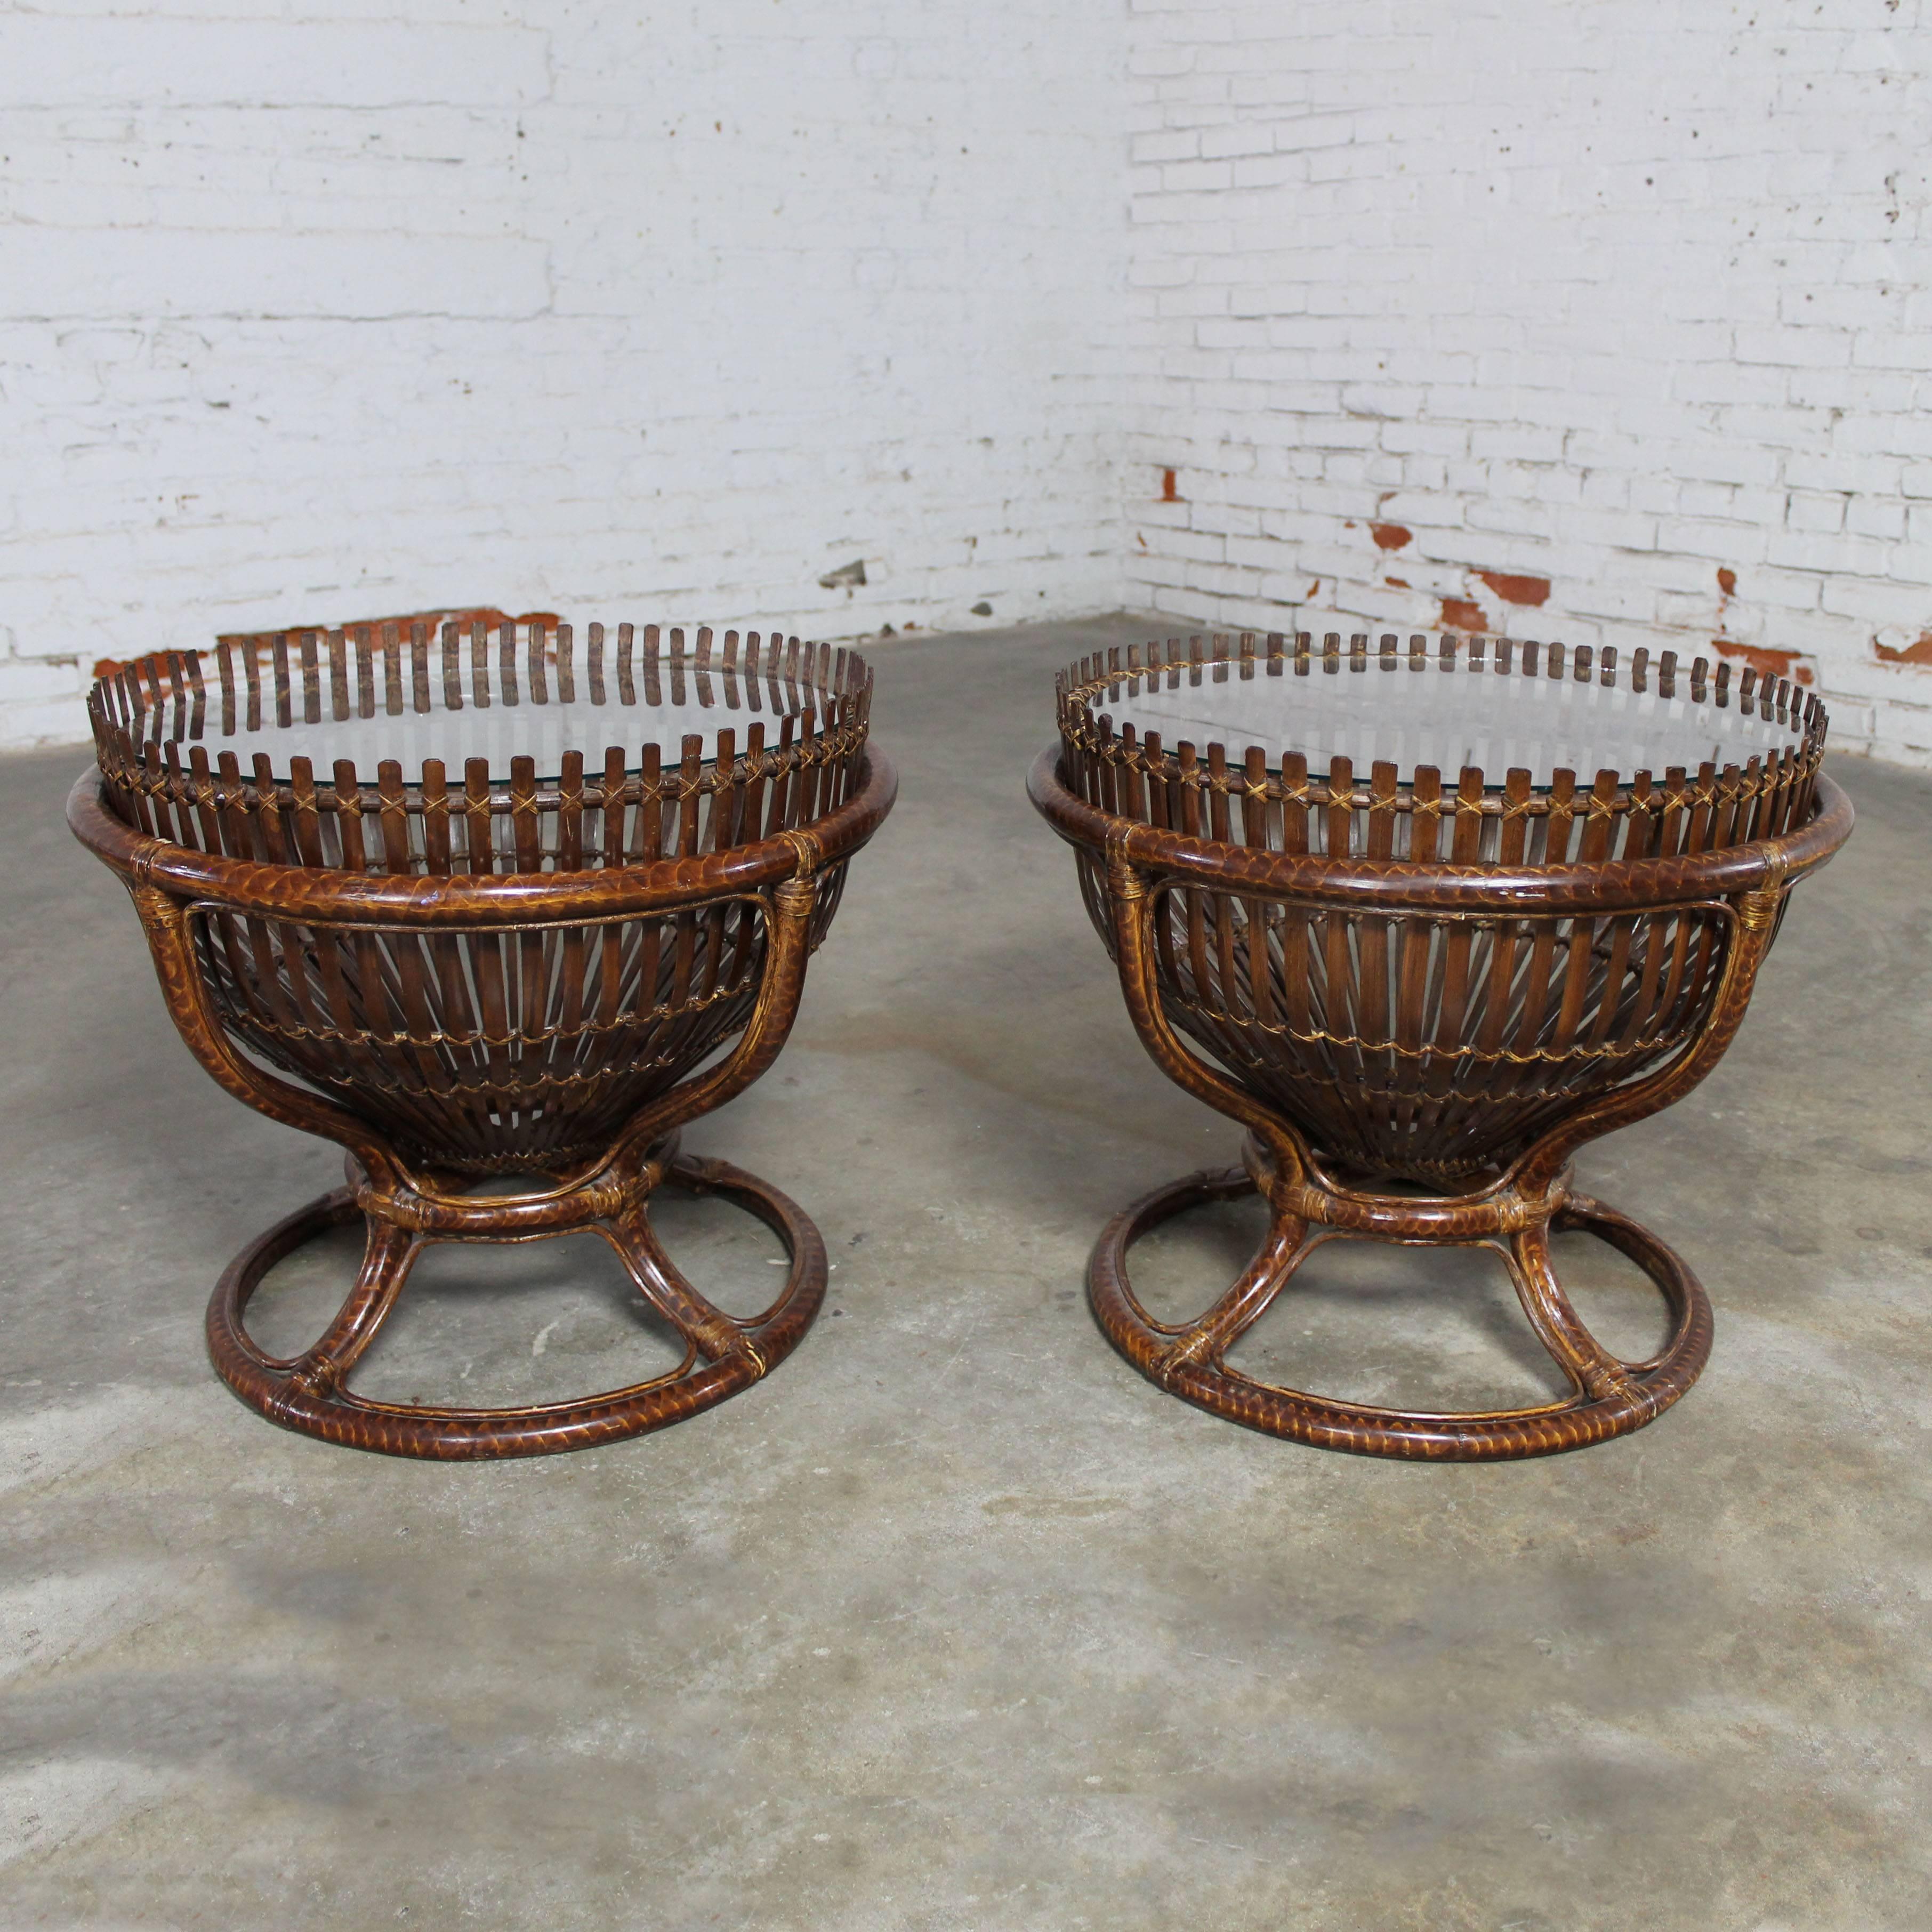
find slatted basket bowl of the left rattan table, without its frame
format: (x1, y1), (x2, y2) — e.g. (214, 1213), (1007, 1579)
(89, 624), (870, 1173)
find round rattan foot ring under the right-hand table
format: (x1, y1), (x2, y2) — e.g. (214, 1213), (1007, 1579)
(1088, 1167), (1712, 1462)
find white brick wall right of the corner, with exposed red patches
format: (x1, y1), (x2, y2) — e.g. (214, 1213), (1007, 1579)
(1123, 0), (1932, 763)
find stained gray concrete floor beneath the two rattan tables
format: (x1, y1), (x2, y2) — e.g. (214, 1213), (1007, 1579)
(0, 620), (1932, 1932)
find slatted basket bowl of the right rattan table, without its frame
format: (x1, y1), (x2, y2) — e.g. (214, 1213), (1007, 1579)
(1059, 638), (1826, 1185)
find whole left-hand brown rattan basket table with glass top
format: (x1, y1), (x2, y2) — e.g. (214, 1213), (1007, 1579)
(68, 624), (897, 1459)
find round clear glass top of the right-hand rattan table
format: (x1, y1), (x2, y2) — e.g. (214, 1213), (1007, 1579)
(1086, 657), (1799, 786)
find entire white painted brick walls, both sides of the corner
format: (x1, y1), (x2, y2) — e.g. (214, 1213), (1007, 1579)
(15, 0), (1932, 763)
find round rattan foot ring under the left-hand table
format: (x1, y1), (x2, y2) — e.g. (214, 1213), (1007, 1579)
(208, 1155), (829, 1461)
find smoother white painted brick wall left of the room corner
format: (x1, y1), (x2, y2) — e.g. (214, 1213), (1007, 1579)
(0, 0), (1126, 744)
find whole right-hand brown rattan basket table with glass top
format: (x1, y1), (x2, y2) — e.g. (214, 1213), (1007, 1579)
(1030, 634), (1853, 1461)
